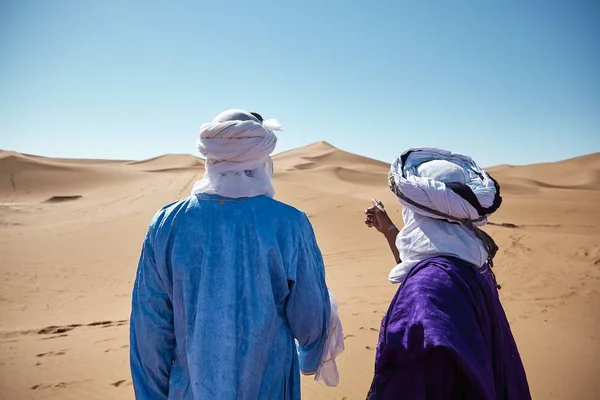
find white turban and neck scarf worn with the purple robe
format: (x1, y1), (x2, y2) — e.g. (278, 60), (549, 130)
(389, 148), (501, 283)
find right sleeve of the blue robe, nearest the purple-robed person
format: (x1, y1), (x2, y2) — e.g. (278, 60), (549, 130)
(286, 216), (331, 374)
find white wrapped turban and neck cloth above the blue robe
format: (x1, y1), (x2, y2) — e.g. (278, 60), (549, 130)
(192, 110), (281, 198)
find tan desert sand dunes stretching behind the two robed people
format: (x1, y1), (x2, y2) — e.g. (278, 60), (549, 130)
(0, 142), (600, 400)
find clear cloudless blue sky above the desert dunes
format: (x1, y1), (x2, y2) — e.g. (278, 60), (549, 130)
(0, 0), (600, 166)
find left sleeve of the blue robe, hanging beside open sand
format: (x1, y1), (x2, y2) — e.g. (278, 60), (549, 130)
(130, 217), (175, 399)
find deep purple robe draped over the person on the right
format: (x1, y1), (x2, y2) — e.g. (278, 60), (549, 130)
(367, 257), (531, 400)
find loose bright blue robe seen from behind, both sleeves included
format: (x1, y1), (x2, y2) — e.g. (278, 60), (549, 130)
(130, 195), (331, 400)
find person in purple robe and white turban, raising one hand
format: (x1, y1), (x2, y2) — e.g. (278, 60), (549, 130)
(365, 148), (531, 400)
